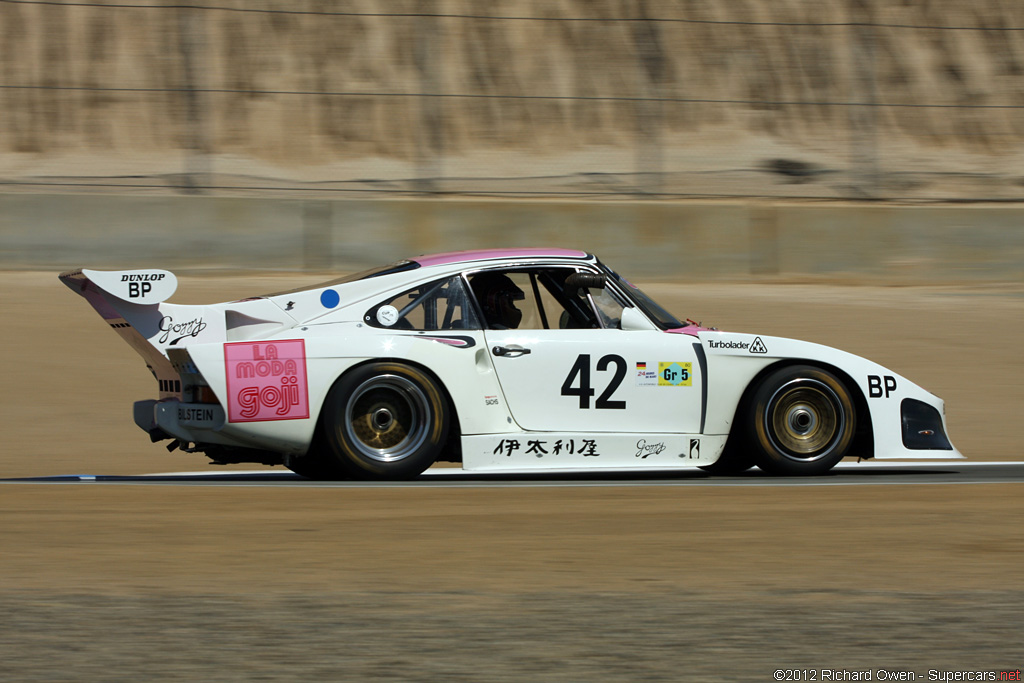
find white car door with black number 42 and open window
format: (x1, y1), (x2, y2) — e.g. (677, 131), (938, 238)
(470, 267), (706, 433)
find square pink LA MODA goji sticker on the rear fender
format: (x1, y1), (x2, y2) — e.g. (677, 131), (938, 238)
(224, 339), (309, 422)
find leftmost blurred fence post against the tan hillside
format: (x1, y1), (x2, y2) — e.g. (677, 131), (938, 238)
(177, 7), (211, 195)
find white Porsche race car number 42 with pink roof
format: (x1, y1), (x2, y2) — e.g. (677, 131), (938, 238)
(60, 249), (963, 478)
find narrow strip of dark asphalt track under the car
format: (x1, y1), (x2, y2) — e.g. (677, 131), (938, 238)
(0, 461), (1024, 488)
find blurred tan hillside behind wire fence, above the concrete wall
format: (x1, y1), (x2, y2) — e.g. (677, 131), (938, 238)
(0, 0), (1024, 202)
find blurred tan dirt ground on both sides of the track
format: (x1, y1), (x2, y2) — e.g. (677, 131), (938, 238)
(0, 272), (1024, 681)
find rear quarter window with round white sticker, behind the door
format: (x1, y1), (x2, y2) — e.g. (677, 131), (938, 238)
(362, 275), (480, 332)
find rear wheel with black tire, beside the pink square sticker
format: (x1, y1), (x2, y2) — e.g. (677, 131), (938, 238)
(322, 361), (451, 479)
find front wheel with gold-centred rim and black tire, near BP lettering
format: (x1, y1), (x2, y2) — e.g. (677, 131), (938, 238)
(741, 366), (857, 476)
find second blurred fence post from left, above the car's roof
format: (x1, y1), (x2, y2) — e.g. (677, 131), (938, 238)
(415, 0), (444, 194)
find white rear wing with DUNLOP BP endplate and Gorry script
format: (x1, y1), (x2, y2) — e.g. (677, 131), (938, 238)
(59, 268), (225, 397)
